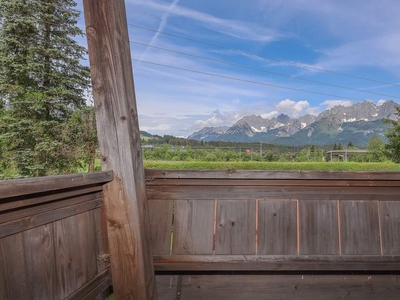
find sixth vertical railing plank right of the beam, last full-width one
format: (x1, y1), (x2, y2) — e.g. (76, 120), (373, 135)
(340, 201), (381, 255)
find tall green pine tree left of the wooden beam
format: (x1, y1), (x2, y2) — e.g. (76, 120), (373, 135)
(0, 0), (90, 176)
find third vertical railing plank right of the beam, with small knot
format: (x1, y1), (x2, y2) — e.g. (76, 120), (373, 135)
(215, 200), (256, 254)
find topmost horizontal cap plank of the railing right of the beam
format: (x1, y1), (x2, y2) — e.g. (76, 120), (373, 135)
(145, 169), (400, 181)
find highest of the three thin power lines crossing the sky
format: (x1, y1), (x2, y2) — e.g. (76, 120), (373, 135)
(128, 23), (400, 87)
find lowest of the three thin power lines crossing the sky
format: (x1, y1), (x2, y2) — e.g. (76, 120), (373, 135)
(132, 59), (365, 101)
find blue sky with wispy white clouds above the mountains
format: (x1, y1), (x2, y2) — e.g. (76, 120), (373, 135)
(78, 0), (400, 136)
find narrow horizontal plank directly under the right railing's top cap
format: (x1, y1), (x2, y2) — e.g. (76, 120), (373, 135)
(146, 178), (400, 188)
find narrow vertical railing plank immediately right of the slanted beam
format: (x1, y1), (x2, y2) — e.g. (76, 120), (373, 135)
(149, 200), (174, 254)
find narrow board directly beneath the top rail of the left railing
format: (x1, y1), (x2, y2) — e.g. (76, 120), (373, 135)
(0, 185), (103, 212)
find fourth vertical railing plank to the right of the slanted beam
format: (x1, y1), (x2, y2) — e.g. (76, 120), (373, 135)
(258, 201), (297, 255)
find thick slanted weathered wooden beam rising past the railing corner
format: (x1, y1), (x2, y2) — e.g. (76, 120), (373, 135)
(83, 0), (157, 299)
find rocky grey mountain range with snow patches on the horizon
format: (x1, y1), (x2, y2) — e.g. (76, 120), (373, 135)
(188, 100), (399, 146)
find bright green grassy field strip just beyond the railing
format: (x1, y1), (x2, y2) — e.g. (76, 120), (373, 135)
(144, 161), (400, 172)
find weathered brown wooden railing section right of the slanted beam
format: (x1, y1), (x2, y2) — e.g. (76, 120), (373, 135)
(146, 170), (400, 299)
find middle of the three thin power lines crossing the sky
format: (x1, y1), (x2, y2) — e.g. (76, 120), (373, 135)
(129, 40), (400, 99)
